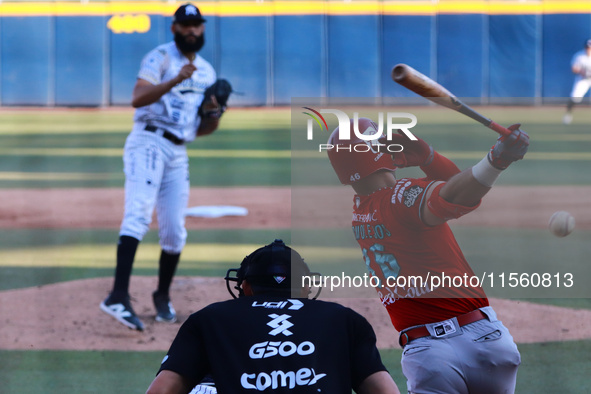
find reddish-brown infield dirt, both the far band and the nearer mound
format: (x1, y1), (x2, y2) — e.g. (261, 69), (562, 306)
(0, 186), (591, 351)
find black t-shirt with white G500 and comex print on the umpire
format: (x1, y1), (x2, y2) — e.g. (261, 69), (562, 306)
(160, 296), (386, 394)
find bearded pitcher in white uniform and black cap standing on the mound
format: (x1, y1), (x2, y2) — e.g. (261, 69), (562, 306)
(100, 4), (219, 331)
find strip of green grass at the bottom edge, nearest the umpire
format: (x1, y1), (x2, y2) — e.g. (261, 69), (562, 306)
(0, 341), (591, 394)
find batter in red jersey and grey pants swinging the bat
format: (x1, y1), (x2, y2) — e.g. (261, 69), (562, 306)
(328, 118), (529, 394)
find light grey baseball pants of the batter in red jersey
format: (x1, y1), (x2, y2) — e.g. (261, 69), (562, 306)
(401, 307), (521, 394)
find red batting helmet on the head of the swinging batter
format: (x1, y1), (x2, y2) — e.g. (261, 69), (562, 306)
(327, 118), (397, 185)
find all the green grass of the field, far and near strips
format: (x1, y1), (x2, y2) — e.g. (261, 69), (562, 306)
(0, 107), (591, 394)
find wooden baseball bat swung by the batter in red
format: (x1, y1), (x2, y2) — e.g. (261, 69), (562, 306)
(392, 63), (511, 135)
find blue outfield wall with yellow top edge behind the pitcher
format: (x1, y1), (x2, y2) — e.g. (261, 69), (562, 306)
(0, 1), (591, 106)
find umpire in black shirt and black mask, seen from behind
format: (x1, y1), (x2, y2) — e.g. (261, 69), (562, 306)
(147, 240), (399, 394)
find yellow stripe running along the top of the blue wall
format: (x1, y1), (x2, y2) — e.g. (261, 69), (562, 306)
(0, 0), (591, 16)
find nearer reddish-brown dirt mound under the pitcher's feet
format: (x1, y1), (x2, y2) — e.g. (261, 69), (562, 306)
(0, 276), (591, 352)
